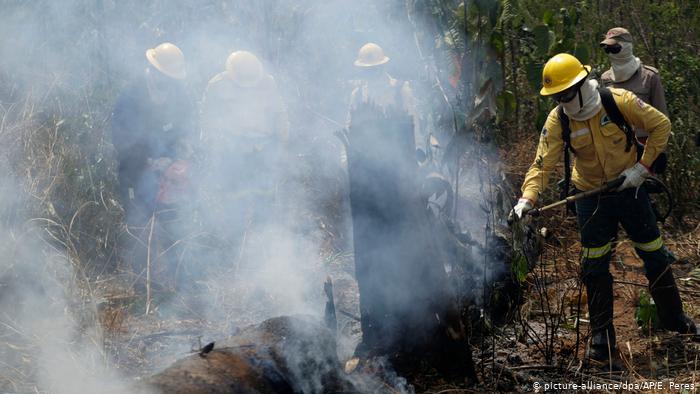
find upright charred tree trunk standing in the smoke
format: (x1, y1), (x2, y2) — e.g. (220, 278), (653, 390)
(346, 104), (476, 379)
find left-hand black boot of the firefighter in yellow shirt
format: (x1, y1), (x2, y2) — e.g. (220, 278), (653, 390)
(584, 272), (616, 362)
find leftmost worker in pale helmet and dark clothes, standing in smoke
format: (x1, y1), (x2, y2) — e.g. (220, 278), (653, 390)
(111, 42), (197, 290)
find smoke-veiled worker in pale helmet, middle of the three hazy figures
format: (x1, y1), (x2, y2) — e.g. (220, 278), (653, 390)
(201, 51), (289, 245)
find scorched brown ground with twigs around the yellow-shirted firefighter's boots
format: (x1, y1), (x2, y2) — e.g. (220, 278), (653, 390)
(460, 220), (700, 392)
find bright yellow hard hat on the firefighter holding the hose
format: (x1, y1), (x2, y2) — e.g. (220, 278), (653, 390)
(540, 53), (591, 96)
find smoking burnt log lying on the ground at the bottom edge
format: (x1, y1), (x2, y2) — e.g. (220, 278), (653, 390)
(142, 316), (356, 394)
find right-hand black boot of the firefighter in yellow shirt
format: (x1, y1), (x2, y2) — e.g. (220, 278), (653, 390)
(647, 266), (698, 335)
